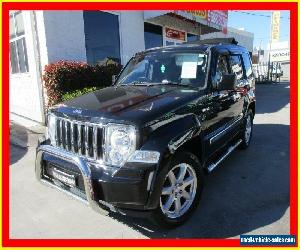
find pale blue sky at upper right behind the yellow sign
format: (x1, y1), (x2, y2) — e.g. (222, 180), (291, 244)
(228, 10), (290, 49)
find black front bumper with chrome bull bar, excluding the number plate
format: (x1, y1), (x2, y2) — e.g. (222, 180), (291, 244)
(35, 141), (157, 214)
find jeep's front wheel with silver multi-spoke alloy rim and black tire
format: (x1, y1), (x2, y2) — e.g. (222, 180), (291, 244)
(152, 151), (204, 228)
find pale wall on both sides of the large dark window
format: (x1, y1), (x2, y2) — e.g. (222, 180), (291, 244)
(44, 11), (145, 64)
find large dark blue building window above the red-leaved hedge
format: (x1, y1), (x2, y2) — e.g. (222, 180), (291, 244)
(83, 11), (121, 64)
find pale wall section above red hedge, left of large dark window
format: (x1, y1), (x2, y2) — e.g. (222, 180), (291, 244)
(44, 11), (86, 62)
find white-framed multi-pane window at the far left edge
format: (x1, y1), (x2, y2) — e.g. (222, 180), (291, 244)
(9, 11), (29, 74)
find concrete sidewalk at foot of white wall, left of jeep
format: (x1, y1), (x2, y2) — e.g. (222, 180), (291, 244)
(9, 121), (45, 148)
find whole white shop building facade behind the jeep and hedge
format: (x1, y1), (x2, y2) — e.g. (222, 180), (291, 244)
(10, 11), (228, 123)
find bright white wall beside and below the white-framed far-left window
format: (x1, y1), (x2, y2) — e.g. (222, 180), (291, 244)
(9, 11), (43, 123)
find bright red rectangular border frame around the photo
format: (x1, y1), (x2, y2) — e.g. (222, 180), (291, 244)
(2, 2), (298, 247)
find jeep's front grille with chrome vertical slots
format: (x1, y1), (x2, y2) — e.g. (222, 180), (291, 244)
(56, 117), (103, 160)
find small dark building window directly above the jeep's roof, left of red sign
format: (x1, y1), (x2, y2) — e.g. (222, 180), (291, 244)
(144, 23), (163, 49)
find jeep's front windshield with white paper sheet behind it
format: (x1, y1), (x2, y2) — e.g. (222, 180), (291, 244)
(117, 52), (207, 88)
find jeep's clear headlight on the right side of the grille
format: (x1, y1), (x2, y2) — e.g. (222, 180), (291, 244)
(104, 124), (136, 167)
